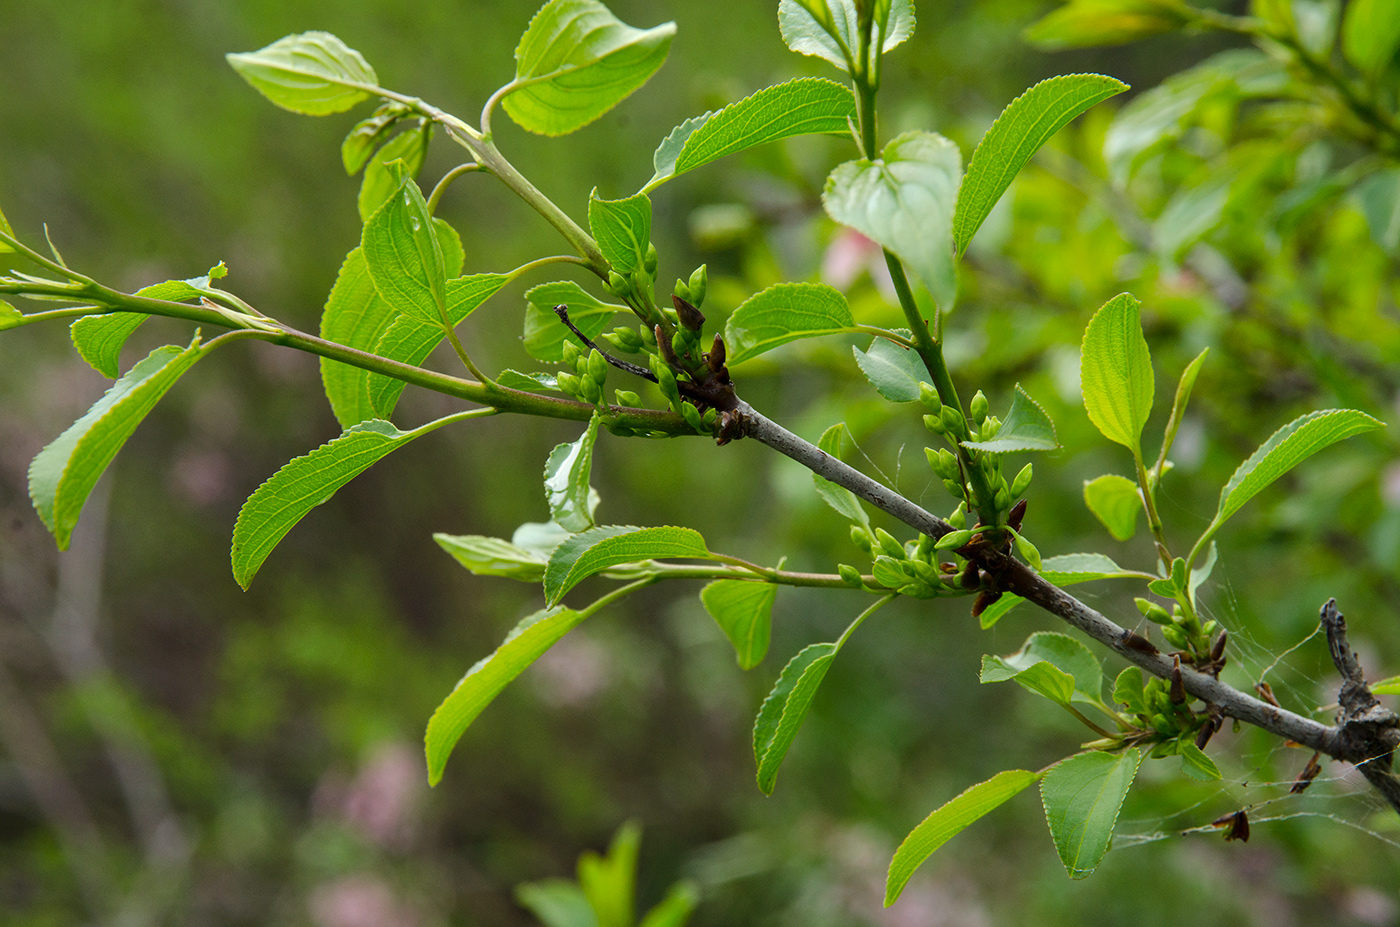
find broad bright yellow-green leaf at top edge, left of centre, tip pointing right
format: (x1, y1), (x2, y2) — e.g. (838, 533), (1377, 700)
(501, 0), (676, 136)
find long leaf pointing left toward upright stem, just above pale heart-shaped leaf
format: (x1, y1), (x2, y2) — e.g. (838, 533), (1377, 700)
(643, 77), (855, 190)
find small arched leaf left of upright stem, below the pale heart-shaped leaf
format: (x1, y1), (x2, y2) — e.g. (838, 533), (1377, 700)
(724, 283), (855, 367)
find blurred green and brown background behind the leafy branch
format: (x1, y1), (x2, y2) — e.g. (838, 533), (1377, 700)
(0, 0), (1400, 927)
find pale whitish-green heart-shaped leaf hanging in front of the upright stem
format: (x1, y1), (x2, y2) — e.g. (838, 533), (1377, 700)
(822, 132), (962, 309)
